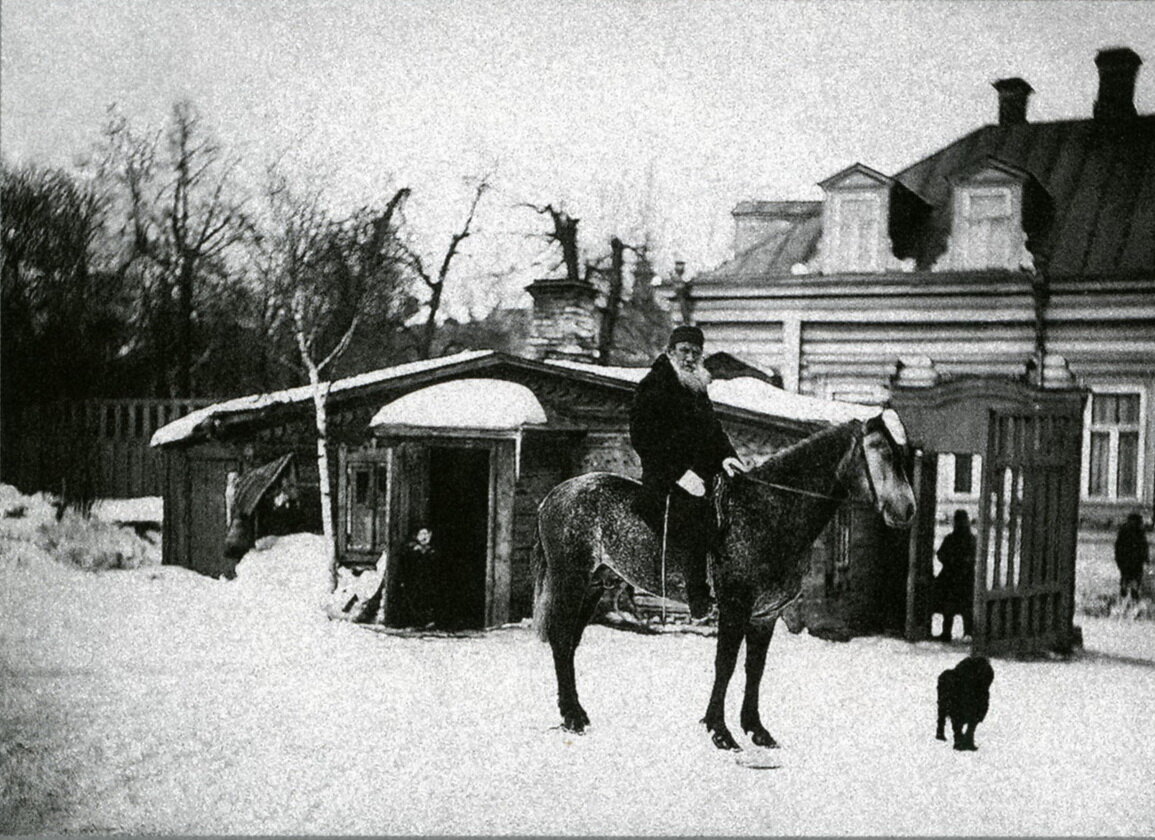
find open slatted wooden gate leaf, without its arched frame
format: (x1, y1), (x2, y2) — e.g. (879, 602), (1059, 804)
(974, 408), (1082, 654)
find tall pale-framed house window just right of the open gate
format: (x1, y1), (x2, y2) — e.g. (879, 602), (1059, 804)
(1087, 392), (1142, 499)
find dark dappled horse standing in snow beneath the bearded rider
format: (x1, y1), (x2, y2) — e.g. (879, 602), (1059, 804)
(534, 410), (915, 750)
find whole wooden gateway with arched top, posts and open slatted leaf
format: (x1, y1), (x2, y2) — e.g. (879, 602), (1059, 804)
(891, 377), (1087, 655)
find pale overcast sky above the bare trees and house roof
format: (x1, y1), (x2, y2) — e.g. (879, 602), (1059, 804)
(0, 0), (1155, 311)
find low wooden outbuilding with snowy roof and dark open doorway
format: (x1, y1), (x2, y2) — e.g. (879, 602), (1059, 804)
(154, 351), (906, 633)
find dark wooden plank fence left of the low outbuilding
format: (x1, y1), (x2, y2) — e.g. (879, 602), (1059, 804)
(0, 400), (215, 499)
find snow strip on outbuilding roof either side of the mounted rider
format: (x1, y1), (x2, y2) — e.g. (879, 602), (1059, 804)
(546, 359), (881, 424)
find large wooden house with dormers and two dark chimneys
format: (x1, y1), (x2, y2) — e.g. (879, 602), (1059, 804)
(684, 47), (1155, 545)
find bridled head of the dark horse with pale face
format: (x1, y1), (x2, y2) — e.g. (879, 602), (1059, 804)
(850, 408), (915, 528)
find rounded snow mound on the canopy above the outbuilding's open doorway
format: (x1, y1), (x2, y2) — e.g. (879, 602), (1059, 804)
(370, 379), (545, 429)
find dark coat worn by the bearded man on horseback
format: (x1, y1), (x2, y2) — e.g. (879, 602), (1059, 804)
(629, 354), (736, 491)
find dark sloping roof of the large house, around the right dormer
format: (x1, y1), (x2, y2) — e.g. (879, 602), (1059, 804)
(895, 114), (1155, 276)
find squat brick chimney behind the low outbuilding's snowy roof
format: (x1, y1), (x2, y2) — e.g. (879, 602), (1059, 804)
(527, 277), (601, 363)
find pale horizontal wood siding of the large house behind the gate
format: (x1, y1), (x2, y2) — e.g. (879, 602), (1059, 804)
(693, 273), (1155, 528)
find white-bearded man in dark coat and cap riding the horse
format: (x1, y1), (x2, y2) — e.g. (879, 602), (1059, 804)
(629, 326), (745, 618)
